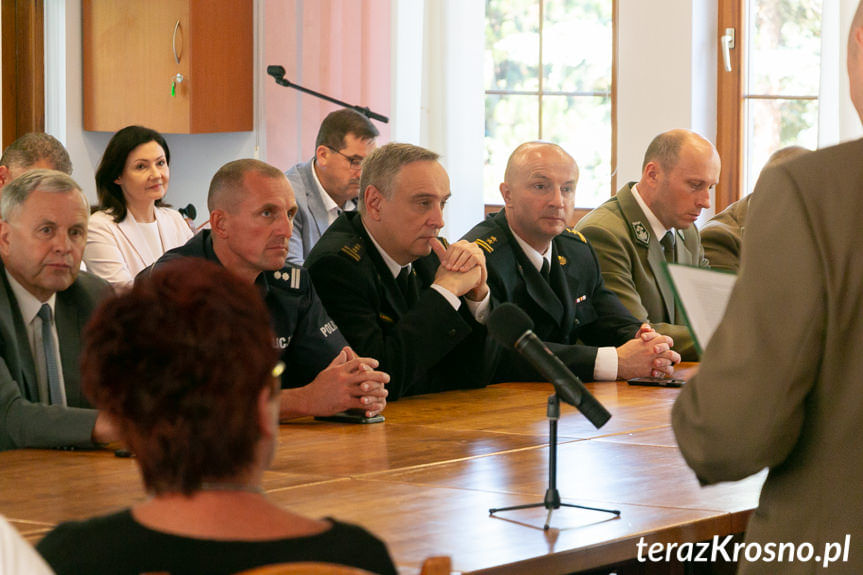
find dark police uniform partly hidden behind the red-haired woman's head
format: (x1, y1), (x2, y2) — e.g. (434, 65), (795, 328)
(152, 230), (348, 388)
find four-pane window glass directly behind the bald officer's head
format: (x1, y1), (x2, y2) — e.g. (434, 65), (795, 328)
(484, 0), (615, 207)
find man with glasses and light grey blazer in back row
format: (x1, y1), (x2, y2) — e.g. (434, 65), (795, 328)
(285, 108), (378, 265)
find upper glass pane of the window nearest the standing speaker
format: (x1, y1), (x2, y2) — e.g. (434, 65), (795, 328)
(745, 0), (821, 96)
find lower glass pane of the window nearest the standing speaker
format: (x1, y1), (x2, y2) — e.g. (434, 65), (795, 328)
(741, 100), (818, 195)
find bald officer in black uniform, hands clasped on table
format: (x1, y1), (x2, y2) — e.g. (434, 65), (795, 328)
(465, 142), (680, 381)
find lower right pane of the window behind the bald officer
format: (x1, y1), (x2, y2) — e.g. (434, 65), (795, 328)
(542, 96), (611, 208)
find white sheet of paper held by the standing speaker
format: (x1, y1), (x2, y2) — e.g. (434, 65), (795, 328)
(666, 264), (737, 354)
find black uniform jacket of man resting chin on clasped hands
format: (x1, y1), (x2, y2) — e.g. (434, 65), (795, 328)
(305, 212), (488, 400)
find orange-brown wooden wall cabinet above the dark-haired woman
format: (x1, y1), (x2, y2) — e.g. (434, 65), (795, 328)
(82, 0), (253, 134)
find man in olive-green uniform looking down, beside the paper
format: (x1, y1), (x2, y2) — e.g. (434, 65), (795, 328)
(575, 130), (720, 361)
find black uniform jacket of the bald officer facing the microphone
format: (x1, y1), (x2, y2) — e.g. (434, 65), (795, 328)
(464, 210), (641, 381)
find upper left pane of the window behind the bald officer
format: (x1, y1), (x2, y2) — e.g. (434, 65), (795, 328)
(485, 0), (539, 91)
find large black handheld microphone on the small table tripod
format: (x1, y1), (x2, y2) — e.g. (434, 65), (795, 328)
(486, 303), (611, 429)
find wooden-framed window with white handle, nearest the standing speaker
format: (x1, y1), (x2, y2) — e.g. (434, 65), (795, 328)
(716, 0), (821, 207)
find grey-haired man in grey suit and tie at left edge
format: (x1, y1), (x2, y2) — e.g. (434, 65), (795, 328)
(0, 170), (116, 449)
